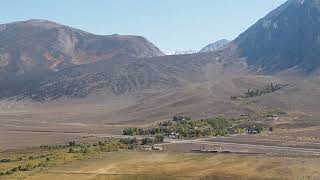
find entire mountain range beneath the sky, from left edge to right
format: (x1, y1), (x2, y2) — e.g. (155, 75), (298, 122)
(0, 0), (320, 100)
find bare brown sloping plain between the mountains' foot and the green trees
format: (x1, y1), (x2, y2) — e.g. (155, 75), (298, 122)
(0, 75), (320, 150)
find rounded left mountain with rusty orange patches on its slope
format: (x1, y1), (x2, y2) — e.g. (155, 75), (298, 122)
(0, 20), (164, 77)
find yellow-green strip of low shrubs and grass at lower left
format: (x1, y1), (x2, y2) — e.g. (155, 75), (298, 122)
(0, 137), (159, 176)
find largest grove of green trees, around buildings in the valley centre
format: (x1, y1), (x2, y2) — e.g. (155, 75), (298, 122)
(123, 116), (261, 139)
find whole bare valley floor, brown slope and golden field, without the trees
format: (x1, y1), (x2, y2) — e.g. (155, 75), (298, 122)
(0, 74), (320, 180)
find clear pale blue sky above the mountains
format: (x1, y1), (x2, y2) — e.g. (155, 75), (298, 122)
(0, 0), (285, 52)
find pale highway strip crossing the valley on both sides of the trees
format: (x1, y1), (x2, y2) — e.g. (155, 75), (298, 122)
(2, 127), (320, 155)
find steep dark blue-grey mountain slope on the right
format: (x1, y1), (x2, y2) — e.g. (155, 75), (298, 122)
(233, 0), (320, 74)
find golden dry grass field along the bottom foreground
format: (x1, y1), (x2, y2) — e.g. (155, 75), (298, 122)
(27, 152), (320, 180)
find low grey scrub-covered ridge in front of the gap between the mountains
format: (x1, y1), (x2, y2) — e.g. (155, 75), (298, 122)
(20, 48), (246, 101)
